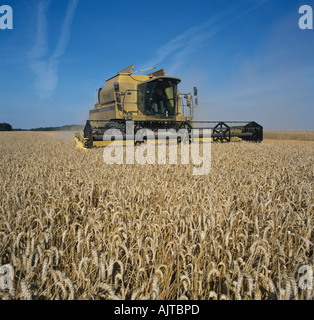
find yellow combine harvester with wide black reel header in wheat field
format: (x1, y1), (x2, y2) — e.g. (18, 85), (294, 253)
(75, 65), (263, 149)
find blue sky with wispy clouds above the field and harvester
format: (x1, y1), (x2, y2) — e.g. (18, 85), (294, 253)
(0, 0), (314, 129)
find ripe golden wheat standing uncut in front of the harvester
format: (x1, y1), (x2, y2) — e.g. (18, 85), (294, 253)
(0, 132), (314, 300)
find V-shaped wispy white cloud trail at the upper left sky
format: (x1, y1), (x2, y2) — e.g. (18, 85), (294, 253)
(28, 0), (79, 99)
